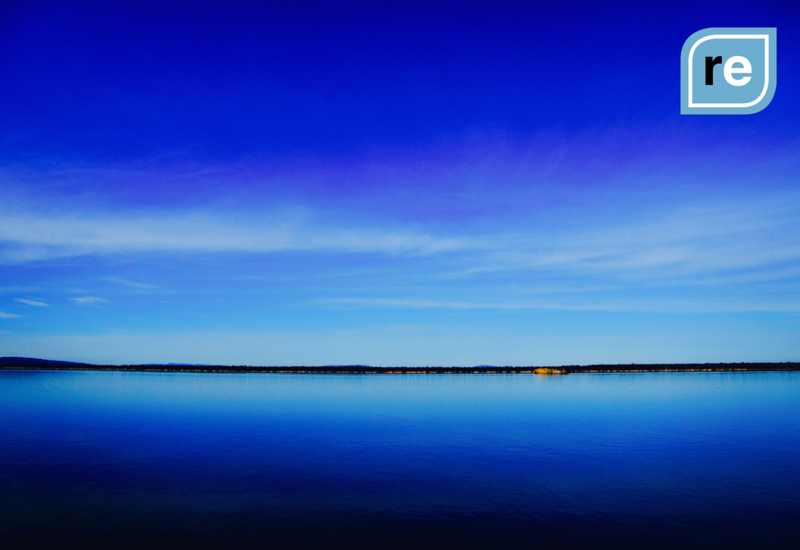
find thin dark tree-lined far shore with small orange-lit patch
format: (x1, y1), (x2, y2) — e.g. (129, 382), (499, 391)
(0, 358), (800, 375)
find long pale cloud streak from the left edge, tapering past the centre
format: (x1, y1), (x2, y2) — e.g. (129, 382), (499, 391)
(0, 213), (470, 263)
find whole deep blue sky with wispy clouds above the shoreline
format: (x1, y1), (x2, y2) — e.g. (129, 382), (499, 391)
(0, 2), (800, 365)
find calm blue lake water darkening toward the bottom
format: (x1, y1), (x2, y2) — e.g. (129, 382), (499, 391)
(0, 371), (800, 548)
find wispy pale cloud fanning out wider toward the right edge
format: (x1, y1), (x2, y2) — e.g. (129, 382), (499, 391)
(454, 201), (800, 282)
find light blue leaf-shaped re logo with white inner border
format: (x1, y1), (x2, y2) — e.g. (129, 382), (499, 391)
(681, 28), (777, 115)
